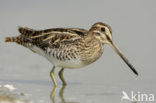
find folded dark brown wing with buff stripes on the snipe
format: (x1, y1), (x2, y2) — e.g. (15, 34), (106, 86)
(19, 27), (88, 49)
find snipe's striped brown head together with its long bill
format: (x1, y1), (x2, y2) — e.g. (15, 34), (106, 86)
(89, 22), (138, 75)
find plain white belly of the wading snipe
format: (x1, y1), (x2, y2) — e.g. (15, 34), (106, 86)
(31, 46), (86, 69)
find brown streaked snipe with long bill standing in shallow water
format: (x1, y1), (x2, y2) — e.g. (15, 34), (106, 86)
(5, 22), (138, 86)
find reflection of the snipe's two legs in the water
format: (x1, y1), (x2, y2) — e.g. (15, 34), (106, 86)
(50, 86), (78, 103)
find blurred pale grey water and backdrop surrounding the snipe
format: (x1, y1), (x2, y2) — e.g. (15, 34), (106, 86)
(0, 0), (156, 103)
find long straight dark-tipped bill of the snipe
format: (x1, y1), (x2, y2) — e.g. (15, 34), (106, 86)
(108, 42), (138, 75)
